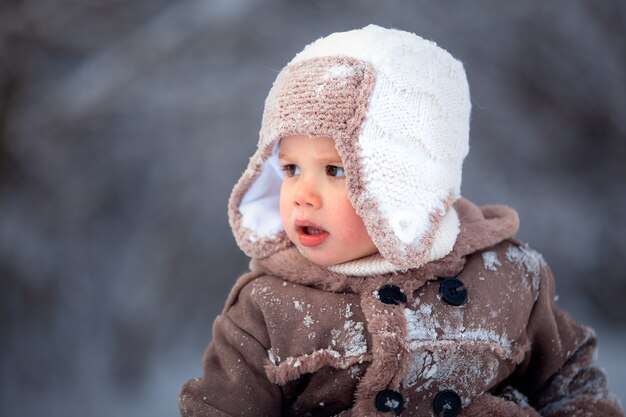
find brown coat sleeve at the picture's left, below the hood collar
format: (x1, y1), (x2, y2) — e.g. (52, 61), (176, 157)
(179, 282), (282, 417)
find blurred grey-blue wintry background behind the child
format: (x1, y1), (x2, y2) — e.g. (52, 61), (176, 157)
(0, 0), (626, 417)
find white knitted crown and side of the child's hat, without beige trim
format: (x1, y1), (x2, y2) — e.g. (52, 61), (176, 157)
(291, 25), (471, 254)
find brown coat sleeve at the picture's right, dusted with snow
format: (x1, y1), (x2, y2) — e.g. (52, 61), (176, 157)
(500, 258), (624, 417)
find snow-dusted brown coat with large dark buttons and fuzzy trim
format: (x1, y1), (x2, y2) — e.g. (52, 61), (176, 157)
(180, 199), (623, 417)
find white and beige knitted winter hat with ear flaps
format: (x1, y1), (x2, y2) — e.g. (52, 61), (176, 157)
(229, 25), (470, 269)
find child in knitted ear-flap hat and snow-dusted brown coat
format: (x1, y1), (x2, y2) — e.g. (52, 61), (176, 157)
(180, 25), (623, 417)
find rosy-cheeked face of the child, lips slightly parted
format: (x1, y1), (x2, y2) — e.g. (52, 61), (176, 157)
(279, 136), (378, 266)
